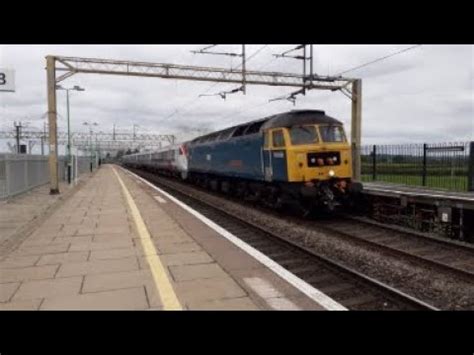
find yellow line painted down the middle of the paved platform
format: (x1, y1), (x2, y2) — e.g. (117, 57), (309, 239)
(112, 168), (183, 310)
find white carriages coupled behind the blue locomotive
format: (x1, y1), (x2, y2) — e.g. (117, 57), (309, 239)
(122, 144), (188, 179)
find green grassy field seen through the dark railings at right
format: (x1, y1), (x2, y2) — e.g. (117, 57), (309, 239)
(362, 174), (468, 191)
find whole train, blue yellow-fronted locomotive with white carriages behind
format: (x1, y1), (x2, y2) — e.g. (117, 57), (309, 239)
(123, 110), (362, 211)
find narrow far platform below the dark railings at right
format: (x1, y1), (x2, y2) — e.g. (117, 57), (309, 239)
(363, 182), (474, 210)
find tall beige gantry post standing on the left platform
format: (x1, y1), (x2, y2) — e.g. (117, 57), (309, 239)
(46, 56), (59, 195)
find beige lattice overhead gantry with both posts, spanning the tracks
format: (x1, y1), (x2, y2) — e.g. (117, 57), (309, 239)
(46, 55), (362, 194)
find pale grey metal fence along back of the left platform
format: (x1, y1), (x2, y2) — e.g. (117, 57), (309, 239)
(0, 154), (96, 200)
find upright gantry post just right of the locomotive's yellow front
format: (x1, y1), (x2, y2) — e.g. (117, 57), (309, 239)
(351, 79), (362, 180)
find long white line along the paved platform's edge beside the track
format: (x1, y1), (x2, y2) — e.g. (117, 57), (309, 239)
(121, 168), (347, 311)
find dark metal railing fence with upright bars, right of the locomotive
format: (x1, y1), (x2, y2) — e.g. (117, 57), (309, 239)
(361, 142), (474, 191)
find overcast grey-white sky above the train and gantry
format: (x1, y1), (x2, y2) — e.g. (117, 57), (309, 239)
(0, 45), (474, 150)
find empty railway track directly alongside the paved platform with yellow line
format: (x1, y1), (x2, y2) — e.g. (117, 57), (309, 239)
(130, 169), (437, 310)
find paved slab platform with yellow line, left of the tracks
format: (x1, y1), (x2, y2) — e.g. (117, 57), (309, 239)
(0, 165), (336, 310)
